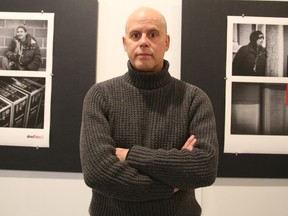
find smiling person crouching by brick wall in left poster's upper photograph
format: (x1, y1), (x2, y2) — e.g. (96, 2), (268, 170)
(2, 25), (42, 71)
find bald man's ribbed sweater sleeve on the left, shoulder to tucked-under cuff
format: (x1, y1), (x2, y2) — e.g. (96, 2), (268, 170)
(80, 84), (173, 201)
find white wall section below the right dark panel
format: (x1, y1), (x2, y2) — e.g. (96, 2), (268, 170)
(202, 177), (288, 216)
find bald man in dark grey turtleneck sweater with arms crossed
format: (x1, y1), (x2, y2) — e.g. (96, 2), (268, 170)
(80, 7), (218, 216)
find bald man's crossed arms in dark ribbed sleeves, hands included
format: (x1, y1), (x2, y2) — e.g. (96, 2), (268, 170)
(80, 83), (217, 202)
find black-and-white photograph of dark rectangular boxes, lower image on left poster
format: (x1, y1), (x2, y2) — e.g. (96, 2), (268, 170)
(0, 76), (45, 129)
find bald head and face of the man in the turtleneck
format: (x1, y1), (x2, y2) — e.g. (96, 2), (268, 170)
(123, 11), (170, 72)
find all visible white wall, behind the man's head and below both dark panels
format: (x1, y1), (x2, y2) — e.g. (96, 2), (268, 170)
(0, 0), (288, 216)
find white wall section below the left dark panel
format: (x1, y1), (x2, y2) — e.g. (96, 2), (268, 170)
(0, 170), (91, 216)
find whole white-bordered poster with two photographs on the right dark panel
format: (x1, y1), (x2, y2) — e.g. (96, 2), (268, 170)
(224, 16), (288, 154)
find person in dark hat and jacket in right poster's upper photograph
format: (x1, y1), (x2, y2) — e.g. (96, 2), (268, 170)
(232, 31), (266, 76)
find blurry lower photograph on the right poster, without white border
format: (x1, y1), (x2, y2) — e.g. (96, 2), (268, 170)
(231, 82), (288, 136)
